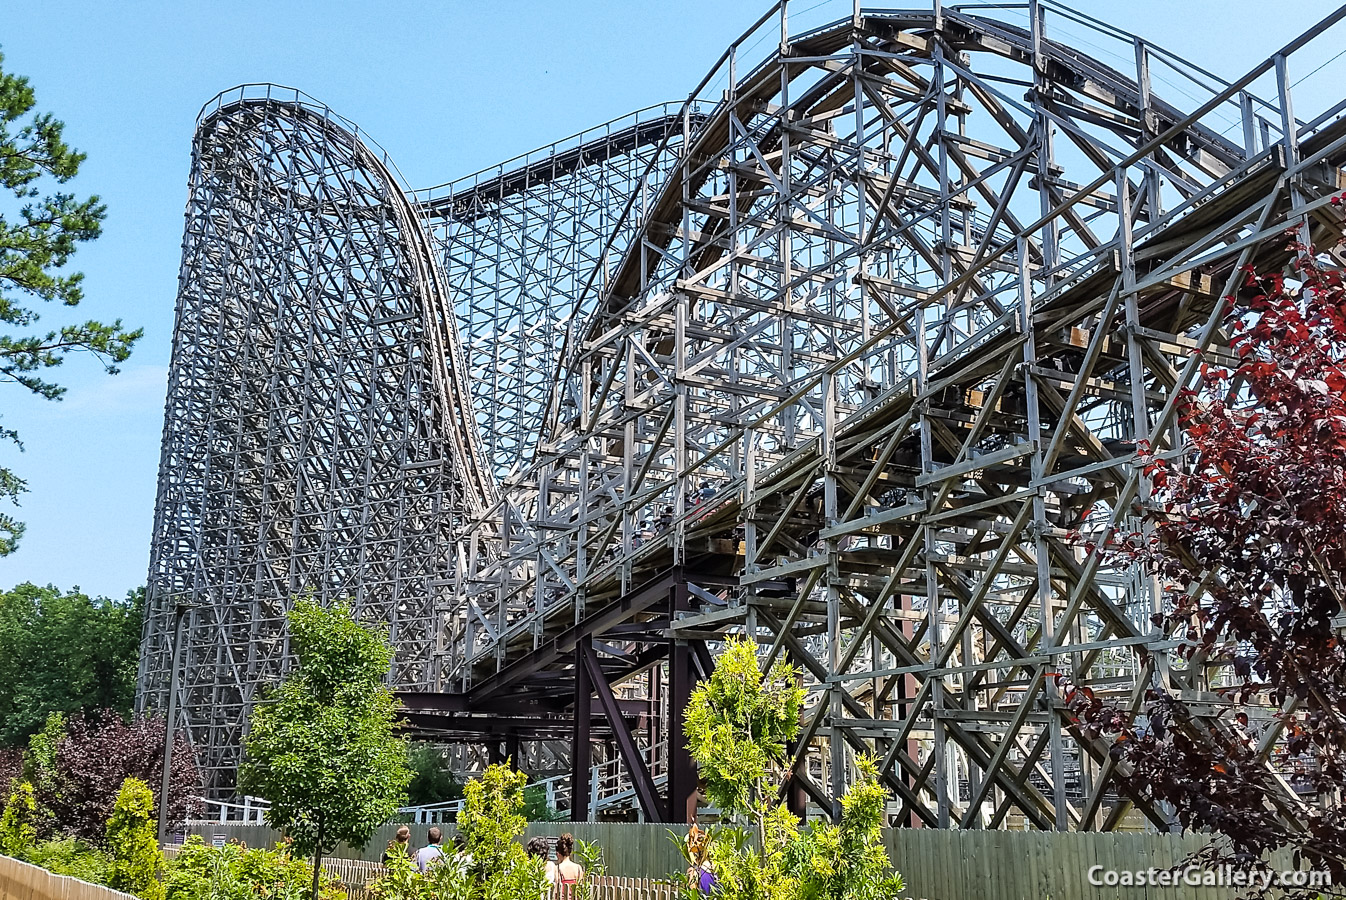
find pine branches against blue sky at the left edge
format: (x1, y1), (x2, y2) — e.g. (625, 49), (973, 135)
(0, 57), (143, 554)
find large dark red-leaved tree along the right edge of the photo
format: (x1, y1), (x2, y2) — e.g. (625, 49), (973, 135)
(1063, 243), (1346, 884)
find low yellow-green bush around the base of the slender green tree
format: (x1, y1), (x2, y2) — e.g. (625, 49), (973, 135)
(164, 834), (346, 900)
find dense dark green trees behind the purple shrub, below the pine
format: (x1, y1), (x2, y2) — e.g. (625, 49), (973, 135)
(0, 584), (144, 747)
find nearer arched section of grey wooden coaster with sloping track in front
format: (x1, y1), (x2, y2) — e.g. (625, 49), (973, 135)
(139, 3), (1346, 829)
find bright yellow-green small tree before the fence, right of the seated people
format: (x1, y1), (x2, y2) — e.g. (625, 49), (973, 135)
(684, 639), (905, 900)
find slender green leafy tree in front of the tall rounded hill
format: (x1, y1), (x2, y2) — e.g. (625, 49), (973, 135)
(238, 600), (411, 897)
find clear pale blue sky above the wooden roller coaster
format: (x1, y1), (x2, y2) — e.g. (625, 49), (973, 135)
(0, 0), (1346, 596)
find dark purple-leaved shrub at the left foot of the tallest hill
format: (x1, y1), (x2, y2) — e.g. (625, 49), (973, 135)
(35, 710), (201, 843)
